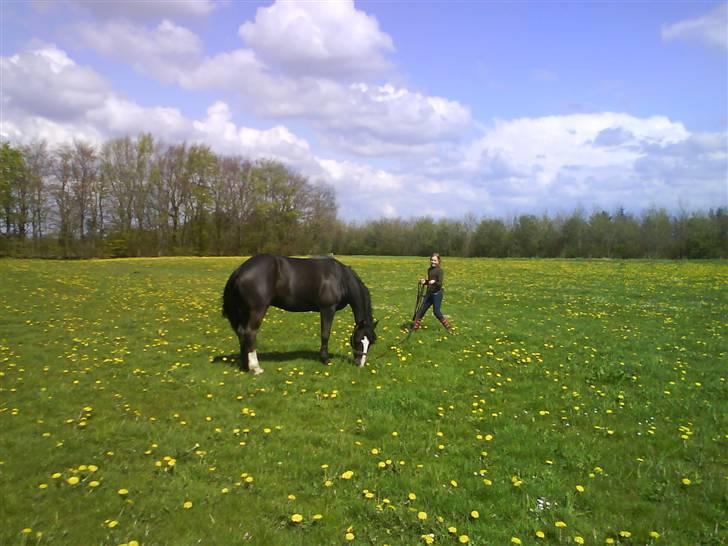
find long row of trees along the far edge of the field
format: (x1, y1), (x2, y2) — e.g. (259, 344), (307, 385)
(0, 134), (728, 259)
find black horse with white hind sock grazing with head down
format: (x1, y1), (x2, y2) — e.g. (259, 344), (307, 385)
(222, 254), (377, 374)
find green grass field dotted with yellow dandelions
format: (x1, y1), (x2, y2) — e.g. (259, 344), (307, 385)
(0, 257), (728, 546)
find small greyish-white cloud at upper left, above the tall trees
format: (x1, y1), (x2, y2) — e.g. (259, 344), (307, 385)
(71, 20), (202, 83)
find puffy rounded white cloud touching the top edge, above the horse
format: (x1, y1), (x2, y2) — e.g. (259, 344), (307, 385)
(239, 0), (394, 78)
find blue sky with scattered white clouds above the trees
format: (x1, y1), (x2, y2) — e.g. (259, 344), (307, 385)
(0, 0), (728, 222)
